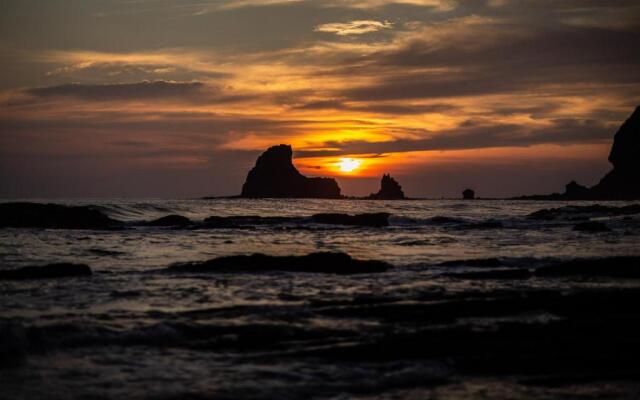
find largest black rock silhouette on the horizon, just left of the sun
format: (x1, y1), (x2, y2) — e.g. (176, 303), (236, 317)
(240, 144), (342, 199)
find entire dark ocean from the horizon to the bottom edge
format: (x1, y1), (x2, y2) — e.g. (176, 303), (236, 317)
(0, 199), (640, 399)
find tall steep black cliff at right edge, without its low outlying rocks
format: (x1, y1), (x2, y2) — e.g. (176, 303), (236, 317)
(591, 106), (640, 200)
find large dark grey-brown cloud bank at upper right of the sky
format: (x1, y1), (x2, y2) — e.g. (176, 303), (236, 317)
(334, 17), (640, 101)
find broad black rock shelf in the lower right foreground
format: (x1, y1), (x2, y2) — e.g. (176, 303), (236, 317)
(306, 289), (640, 375)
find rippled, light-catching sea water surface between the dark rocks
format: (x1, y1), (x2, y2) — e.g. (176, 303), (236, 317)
(0, 199), (640, 399)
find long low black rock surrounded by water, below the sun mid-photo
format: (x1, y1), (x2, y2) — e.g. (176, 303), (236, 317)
(169, 253), (392, 275)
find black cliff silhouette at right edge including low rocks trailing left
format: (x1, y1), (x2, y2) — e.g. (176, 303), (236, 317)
(520, 106), (640, 200)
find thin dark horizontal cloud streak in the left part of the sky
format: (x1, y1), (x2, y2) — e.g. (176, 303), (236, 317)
(27, 81), (204, 100)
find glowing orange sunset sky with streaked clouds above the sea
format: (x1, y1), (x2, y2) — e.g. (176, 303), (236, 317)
(0, 0), (640, 197)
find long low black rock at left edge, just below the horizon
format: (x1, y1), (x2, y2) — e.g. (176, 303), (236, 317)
(0, 203), (122, 229)
